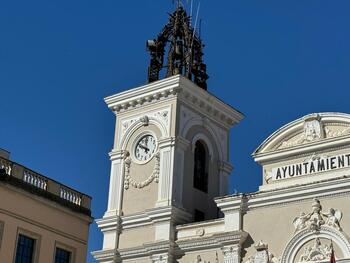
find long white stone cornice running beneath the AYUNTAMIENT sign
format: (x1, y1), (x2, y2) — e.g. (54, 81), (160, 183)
(215, 176), (350, 210)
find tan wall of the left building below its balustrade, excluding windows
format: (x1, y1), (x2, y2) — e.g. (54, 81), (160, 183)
(0, 185), (90, 263)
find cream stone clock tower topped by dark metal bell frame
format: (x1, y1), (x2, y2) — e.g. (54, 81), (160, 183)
(94, 6), (243, 263)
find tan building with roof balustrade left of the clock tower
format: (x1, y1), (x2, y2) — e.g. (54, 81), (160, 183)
(0, 150), (92, 263)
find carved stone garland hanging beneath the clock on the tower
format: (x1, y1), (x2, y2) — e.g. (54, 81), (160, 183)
(124, 152), (160, 190)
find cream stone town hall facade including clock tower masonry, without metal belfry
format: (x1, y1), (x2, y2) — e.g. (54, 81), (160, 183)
(93, 76), (350, 263)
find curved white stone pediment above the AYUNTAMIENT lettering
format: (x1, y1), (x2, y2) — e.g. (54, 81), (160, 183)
(253, 112), (350, 163)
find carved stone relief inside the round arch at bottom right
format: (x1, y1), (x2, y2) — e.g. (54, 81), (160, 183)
(299, 238), (332, 263)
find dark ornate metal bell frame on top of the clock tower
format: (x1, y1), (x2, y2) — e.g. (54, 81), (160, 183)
(147, 5), (209, 90)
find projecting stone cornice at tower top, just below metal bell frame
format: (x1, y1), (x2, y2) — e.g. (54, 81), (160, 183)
(105, 75), (243, 127)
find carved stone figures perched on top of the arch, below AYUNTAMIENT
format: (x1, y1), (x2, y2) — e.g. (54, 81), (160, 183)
(293, 199), (342, 232)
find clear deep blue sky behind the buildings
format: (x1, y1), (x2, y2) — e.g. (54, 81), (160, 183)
(0, 0), (350, 262)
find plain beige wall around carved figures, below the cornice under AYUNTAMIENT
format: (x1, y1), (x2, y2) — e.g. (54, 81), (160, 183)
(242, 195), (350, 262)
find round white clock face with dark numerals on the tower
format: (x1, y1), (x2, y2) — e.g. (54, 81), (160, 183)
(131, 131), (158, 164)
